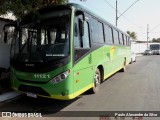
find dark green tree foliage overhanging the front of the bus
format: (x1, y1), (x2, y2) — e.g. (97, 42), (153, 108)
(0, 0), (68, 19)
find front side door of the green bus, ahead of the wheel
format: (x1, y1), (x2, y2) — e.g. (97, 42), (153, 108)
(74, 15), (94, 95)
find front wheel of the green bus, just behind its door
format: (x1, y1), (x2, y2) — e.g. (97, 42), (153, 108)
(91, 68), (101, 94)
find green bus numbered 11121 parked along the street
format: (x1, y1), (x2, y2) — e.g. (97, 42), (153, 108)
(4, 4), (131, 100)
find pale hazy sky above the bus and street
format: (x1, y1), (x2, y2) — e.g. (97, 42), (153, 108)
(69, 0), (160, 41)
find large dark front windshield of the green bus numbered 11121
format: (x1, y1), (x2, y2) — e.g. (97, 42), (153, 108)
(11, 11), (70, 62)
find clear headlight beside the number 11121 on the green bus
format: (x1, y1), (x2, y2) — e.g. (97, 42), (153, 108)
(51, 70), (70, 84)
